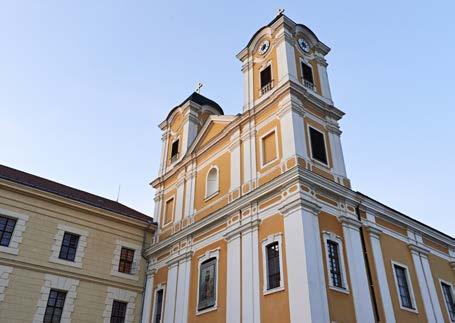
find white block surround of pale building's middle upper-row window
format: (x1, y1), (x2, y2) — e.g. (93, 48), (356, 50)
(49, 224), (88, 268)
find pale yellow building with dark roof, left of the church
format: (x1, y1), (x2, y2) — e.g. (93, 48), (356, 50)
(0, 165), (155, 323)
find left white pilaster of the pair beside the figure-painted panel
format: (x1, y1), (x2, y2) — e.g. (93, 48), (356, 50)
(226, 232), (242, 323)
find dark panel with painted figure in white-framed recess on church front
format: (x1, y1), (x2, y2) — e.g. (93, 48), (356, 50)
(198, 258), (217, 311)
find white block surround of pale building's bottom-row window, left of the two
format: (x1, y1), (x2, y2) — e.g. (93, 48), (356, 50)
(33, 274), (79, 323)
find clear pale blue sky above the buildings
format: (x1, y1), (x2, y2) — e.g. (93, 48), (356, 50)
(0, 0), (455, 236)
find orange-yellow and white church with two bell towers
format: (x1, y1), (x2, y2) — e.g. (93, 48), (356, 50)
(142, 13), (455, 323)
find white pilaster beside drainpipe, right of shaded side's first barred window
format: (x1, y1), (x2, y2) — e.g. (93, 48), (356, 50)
(340, 216), (375, 323)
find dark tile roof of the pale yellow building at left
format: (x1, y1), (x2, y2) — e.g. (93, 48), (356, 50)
(0, 165), (153, 223)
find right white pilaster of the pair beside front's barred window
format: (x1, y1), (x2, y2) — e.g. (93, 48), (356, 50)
(241, 220), (261, 323)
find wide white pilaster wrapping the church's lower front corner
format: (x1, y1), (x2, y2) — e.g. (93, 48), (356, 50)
(280, 195), (329, 323)
